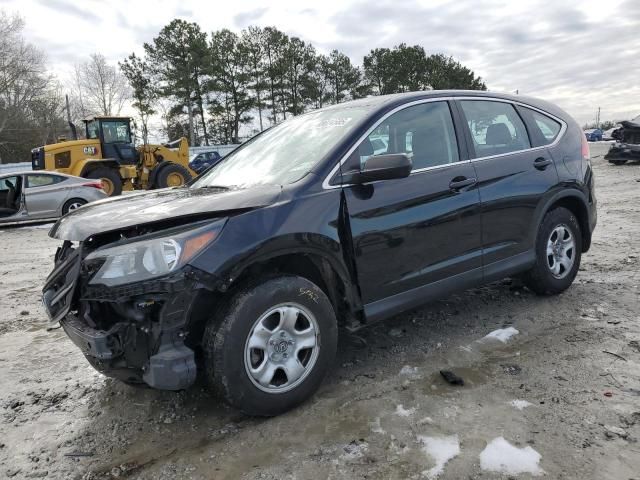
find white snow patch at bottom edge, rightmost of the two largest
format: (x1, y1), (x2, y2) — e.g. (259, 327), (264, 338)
(480, 437), (544, 476)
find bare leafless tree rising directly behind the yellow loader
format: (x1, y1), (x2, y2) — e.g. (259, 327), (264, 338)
(75, 53), (131, 115)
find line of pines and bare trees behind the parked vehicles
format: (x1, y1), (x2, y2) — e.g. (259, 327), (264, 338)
(0, 11), (486, 163)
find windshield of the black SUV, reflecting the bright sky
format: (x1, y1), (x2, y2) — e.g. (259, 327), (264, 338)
(193, 105), (370, 188)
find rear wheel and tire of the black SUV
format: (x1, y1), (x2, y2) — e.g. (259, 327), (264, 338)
(522, 207), (582, 295)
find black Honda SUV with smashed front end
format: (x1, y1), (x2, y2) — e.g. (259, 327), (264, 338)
(43, 91), (596, 415)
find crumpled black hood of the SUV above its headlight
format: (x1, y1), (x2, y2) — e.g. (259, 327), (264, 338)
(49, 185), (281, 241)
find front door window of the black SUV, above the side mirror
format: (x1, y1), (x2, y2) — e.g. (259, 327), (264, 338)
(350, 102), (460, 170)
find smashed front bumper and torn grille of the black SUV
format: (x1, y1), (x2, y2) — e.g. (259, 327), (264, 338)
(43, 245), (210, 390)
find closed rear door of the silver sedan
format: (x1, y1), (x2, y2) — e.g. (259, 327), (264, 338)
(25, 173), (68, 218)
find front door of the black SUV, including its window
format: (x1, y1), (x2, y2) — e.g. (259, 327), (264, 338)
(342, 101), (482, 317)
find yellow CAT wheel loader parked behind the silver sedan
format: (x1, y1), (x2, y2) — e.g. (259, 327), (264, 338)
(31, 117), (196, 196)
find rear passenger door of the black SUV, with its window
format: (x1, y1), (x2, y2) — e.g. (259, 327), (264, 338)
(459, 99), (558, 277)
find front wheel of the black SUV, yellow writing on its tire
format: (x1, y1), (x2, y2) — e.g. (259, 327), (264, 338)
(203, 276), (338, 416)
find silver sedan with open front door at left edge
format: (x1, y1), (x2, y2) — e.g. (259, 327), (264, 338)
(0, 172), (107, 223)
